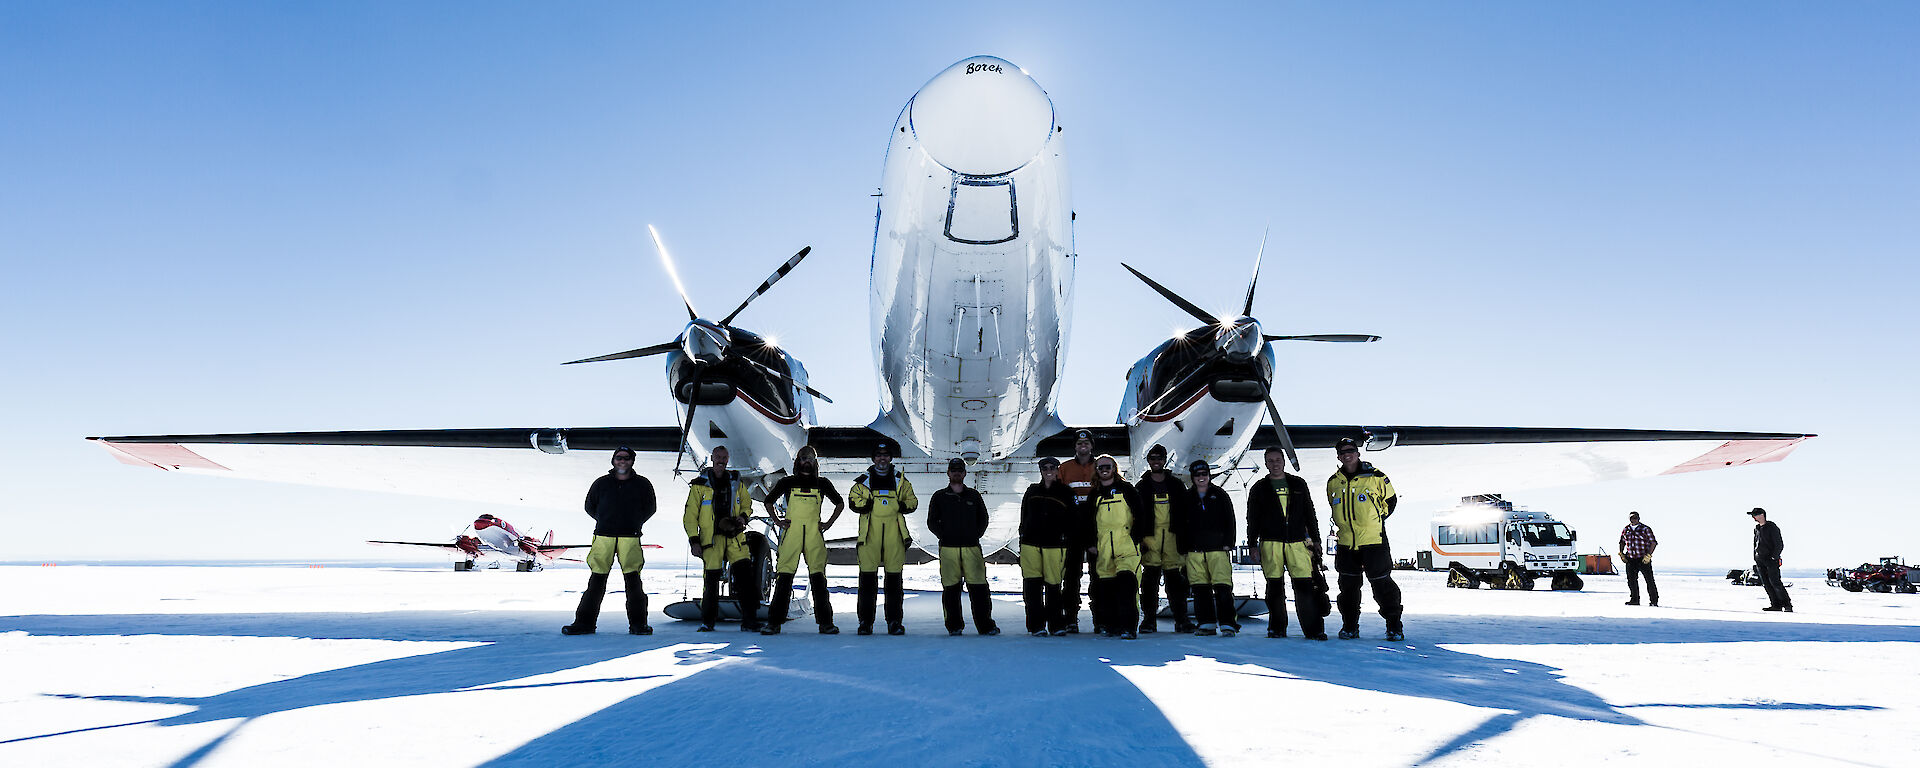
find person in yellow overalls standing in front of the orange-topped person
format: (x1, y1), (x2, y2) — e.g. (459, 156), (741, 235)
(1079, 453), (1154, 639)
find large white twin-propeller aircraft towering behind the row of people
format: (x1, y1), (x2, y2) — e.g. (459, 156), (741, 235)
(90, 56), (1812, 561)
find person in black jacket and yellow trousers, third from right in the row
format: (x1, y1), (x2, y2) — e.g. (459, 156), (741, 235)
(1173, 461), (1240, 637)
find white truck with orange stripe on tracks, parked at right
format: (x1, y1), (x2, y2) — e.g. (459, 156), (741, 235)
(1428, 493), (1582, 589)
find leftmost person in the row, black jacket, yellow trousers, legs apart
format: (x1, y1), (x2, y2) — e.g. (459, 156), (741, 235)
(561, 445), (657, 636)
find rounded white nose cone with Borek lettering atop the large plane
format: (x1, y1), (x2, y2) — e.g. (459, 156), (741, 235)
(908, 56), (1054, 177)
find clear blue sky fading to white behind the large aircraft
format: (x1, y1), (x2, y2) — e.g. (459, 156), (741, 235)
(0, 2), (1920, 568)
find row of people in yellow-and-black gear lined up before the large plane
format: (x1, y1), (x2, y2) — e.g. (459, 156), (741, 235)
(561, 430), (1404, 639)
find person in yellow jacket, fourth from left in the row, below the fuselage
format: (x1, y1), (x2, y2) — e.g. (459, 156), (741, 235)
(847, 444), (920, 636)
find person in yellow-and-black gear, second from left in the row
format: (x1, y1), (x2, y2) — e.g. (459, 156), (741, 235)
(680, 445), (760, 632)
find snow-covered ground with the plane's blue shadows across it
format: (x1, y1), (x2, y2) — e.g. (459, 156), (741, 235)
(0, 566), (1920, 768)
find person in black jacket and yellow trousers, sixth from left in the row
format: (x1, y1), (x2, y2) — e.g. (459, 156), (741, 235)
(1020, 457), (1075, 637)
